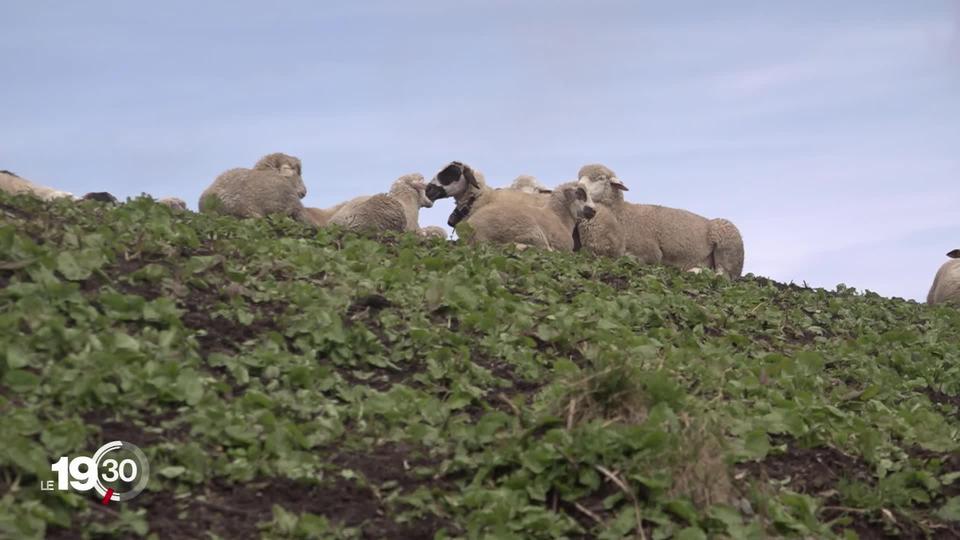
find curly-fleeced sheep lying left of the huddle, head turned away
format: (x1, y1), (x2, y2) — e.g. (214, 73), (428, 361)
(198, 153), (312, 225)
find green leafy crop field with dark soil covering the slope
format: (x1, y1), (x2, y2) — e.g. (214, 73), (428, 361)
(0, 195), (960, 540)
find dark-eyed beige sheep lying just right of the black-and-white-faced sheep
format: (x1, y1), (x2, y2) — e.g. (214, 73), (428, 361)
(467, 182), (595, 251)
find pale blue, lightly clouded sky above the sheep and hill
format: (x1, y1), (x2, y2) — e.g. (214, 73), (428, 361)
(0, 0), (960, 300)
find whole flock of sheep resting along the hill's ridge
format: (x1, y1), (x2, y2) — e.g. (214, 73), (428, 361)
(0, 153), (960, 305)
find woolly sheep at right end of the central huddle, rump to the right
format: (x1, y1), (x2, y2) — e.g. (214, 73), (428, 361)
(578, 164), (743, 278)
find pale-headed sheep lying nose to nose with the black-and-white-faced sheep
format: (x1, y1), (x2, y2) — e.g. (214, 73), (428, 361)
(329, 173), (433, 232)
